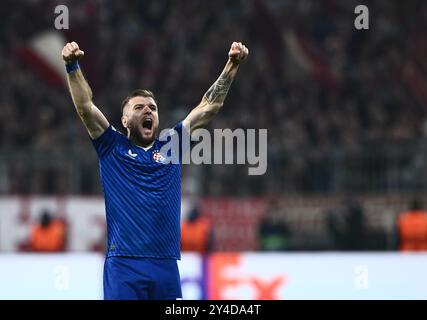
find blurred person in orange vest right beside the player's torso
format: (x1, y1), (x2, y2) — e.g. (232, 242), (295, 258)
(181, 206), (213, 253)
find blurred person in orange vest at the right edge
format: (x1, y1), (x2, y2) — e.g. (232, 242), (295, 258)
(397, 199), (427, 251)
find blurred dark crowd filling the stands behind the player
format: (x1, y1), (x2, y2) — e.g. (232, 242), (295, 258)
(0, 0), (427, 196)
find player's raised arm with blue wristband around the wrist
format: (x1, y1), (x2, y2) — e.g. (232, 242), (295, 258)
(62, 42), (110, 139)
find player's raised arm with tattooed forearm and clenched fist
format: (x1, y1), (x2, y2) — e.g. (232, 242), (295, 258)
(183, 42), (249, 132)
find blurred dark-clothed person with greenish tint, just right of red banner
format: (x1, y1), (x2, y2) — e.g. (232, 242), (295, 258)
(258, 202), (290, 251)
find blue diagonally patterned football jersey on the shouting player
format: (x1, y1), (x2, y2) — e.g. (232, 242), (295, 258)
(92, 122), (183, 259)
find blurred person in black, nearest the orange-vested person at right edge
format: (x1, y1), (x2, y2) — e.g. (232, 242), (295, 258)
(327, 200), (370, 251)
